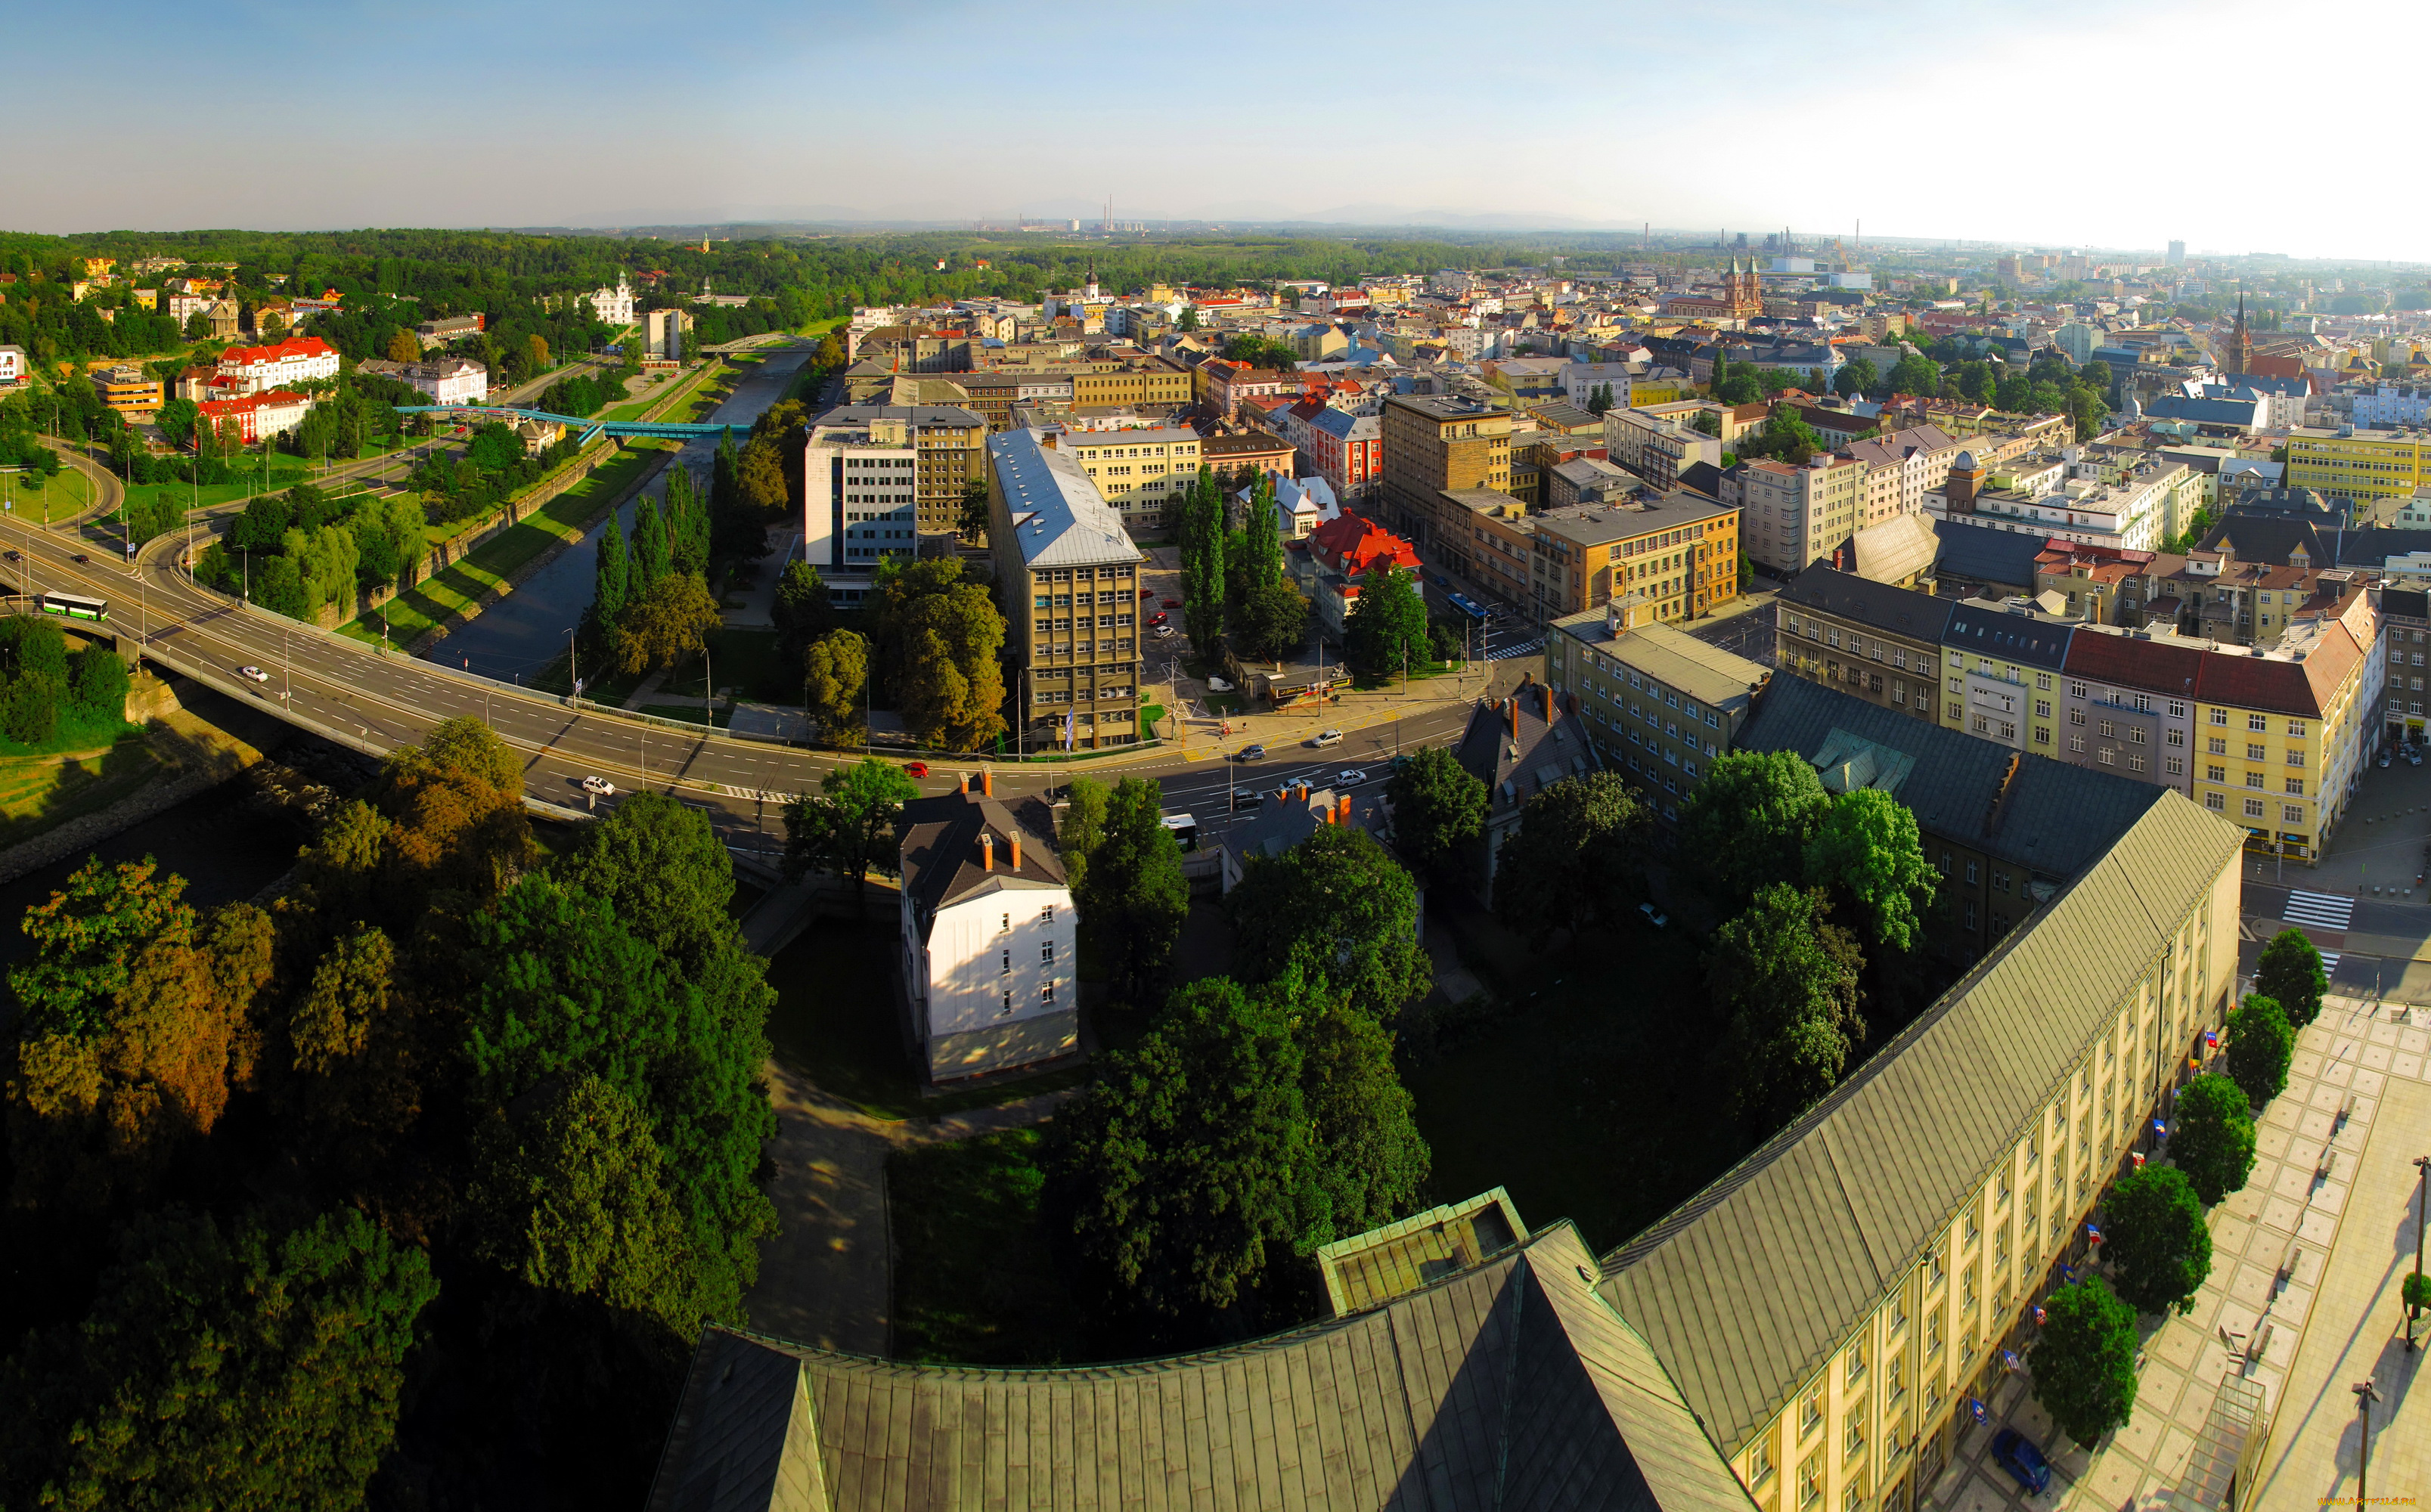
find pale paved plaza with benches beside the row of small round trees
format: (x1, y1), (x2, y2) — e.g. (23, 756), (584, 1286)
(1925, 996), (2431, 1512)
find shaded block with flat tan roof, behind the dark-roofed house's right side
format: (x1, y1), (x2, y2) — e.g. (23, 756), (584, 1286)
(1544, 606), (1772, 820)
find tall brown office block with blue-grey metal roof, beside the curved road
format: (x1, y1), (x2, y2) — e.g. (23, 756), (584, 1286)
(987, 430), (1145, 751)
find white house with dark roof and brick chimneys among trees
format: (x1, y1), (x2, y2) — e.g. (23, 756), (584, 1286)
(897, 770), (1079, 1082)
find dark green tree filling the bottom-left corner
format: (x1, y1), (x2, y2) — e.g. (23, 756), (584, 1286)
(0, 1210), (438, 1507)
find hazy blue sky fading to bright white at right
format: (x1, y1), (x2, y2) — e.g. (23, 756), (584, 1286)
(0, 0), (2431, 260)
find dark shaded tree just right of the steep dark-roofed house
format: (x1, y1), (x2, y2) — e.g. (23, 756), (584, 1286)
(1493, 770), (1653, 943)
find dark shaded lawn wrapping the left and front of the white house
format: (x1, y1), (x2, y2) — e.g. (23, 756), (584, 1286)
(768, 914), (1087, 1118)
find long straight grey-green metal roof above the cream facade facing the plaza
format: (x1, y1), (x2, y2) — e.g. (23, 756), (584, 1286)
(1602, 792), (2243, 1454)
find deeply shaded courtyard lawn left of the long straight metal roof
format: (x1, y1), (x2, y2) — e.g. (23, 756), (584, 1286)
(1403, 909), (1750, 1254)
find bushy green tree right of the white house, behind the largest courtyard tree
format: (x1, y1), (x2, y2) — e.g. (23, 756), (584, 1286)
(1223, 824), (1434, 1021)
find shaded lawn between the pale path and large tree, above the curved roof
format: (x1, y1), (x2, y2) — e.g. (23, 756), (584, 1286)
(887, 1128), (1101, 1366)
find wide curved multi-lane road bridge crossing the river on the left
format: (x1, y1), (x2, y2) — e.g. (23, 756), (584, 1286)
(14, 428), (1466, 866)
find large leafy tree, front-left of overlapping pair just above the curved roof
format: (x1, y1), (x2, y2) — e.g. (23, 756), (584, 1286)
(1048, 978), (1313, 1325)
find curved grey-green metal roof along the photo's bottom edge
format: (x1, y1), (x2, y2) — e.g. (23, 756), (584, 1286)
(649, 1222), (1753, 1512)
